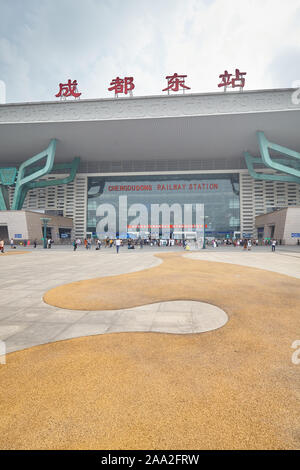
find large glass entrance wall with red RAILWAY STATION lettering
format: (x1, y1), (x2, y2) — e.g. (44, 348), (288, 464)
(87, 173), (240, 238)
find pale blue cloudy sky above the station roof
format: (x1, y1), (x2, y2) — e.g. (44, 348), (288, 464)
(0, 0), (300, 102)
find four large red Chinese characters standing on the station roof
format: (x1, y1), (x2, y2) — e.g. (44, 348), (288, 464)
(55, 69), (247, 100)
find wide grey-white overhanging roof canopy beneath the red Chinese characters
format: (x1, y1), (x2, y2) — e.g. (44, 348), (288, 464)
(0, 90), (300, 165)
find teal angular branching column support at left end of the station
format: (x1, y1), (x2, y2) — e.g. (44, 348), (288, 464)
(0, 139), (80, 210)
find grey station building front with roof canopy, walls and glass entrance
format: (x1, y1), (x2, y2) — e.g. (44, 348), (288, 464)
(0, 89), (300, 242)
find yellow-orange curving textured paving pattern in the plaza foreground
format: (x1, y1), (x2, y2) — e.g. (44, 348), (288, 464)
(0, 254), (300, 449)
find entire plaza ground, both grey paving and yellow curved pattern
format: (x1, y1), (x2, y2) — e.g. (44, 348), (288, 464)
(0, 247), (300, 449)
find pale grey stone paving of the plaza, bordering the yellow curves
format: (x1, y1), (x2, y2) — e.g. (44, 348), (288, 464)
(0, 247), (300, 352)
